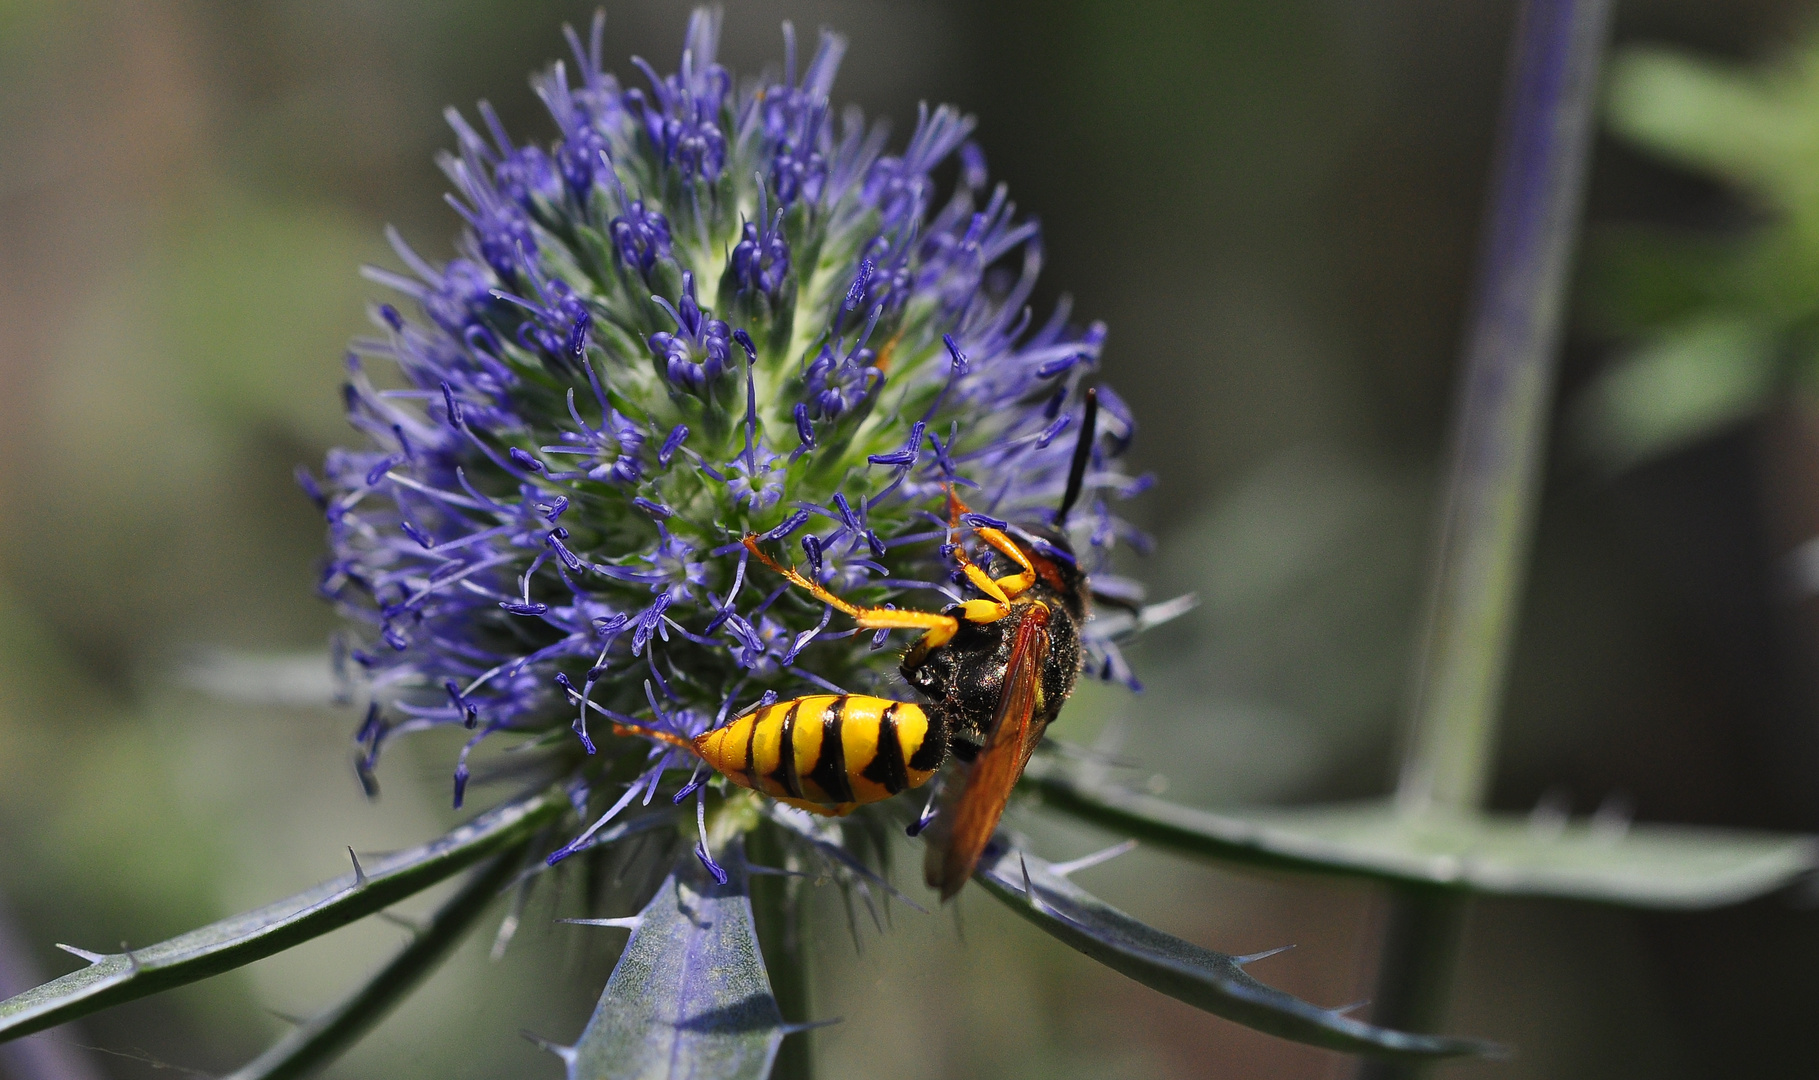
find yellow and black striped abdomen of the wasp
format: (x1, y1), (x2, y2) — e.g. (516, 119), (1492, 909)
(695, 695), (946, 813)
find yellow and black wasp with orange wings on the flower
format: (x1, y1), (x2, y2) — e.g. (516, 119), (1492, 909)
(618, 389), (1099, 900)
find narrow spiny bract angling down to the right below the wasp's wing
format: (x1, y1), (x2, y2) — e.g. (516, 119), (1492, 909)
(975, 836), (1502, 1058)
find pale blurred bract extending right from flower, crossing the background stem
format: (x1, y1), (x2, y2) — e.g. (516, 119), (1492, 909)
(1026, 758), (1819, 911)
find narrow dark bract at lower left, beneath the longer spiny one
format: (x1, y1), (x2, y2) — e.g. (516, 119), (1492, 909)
(227, 851), (520, 1080)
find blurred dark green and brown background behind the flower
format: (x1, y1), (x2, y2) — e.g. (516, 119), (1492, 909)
(0, 0), (1819, 1080)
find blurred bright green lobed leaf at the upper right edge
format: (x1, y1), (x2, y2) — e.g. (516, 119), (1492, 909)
(1577, 38), (1819, 469)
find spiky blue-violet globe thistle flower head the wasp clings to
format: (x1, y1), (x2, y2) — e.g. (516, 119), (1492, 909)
(309, 4), (1142, 836)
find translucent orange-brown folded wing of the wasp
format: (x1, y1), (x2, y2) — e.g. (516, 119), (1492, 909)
(922, 604), (1048, 900)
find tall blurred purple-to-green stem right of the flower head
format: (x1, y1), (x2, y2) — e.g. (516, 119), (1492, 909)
(1359, 0), (1612, 1061)
